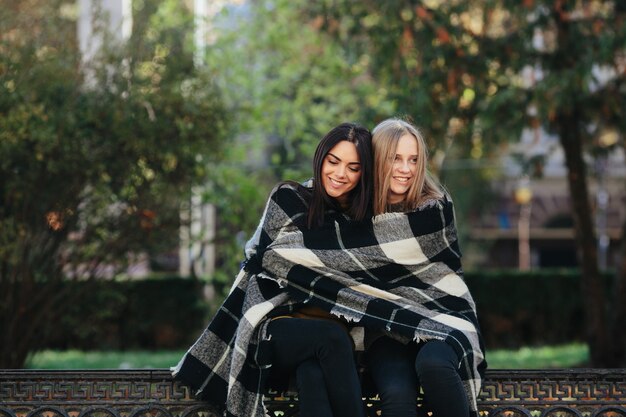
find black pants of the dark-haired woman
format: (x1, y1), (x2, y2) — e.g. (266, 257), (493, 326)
(268, 318), (365, 417)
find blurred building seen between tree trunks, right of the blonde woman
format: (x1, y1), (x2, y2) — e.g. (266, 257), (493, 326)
(470, 126), (626, 269)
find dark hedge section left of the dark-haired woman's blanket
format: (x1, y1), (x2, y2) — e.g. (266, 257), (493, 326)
(48, 277), (210, 350)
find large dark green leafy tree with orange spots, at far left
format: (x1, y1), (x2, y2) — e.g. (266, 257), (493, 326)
(0, 0), (228, 368)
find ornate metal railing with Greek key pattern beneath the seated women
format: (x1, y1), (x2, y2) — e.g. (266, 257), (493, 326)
(0, 369), (626, 417)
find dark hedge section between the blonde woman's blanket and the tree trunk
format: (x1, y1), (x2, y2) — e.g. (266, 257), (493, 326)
(465, 269), (610, 349)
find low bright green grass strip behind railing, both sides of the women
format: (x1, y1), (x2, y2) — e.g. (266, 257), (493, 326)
(25, 343), (589, 369)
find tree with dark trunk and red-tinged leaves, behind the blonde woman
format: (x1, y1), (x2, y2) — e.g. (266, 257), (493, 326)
(306, 0), (626, 366)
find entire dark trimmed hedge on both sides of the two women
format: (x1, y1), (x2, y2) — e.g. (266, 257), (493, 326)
(48, 270), (609, 350)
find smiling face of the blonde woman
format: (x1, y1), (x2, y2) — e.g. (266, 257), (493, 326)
(388, 134), (418, 204)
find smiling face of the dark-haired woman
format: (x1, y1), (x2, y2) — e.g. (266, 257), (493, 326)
(322, 140), (361, 206)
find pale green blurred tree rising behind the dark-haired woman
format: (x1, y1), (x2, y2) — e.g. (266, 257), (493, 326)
(195, 0), (394, 288)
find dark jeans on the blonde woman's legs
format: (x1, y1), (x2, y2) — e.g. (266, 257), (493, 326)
(366, 337), (469, 417)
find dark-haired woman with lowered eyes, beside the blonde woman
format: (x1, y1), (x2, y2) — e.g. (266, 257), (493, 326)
(173, 123), (372, 417)
